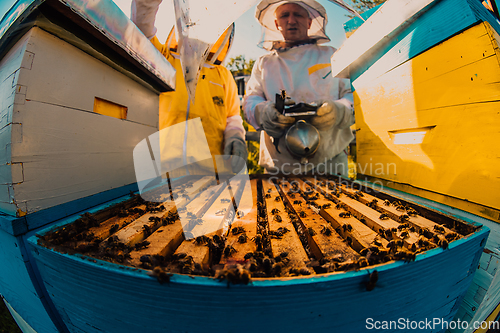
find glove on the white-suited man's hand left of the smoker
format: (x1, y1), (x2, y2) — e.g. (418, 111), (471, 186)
(255, 102), (295, 139)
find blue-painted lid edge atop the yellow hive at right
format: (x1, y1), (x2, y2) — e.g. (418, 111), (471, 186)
(346, 0), (500, 86)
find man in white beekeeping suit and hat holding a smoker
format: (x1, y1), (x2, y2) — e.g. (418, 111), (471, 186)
(243, 0), (354, 176)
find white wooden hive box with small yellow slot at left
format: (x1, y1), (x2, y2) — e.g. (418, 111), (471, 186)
(0, 27), (162, 216)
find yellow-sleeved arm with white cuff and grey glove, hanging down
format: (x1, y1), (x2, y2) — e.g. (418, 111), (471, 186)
(221, 66), (248, 173)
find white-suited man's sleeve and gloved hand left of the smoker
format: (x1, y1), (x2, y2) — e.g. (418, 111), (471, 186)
(243, 58), (295, 138)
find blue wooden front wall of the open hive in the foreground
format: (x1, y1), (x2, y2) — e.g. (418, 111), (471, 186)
(28, 206), (489, 333)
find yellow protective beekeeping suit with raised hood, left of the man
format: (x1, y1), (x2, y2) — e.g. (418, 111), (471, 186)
(151, 27), (240, 156)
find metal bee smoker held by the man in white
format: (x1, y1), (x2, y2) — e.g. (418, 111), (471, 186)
(274, 90), (320, 164)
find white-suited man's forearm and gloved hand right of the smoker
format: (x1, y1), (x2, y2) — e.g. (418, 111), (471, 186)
(311, 79), (355, 130)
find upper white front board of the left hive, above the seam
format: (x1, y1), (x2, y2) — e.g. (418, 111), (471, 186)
(14, 28), (158, 127)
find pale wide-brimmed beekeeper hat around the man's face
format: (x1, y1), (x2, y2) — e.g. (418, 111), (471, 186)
(255, 0), (330, 50)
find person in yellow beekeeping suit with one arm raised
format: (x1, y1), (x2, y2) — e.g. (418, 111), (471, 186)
(131, 0), (248, 172)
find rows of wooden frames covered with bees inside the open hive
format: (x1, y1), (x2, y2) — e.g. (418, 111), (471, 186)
(39, 177), (475, 284)
